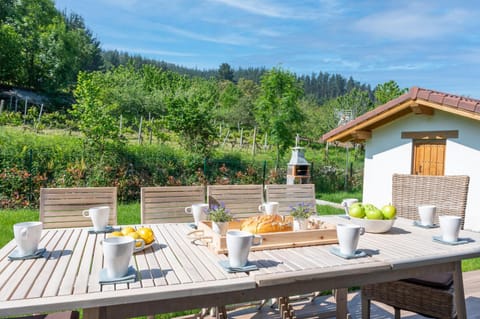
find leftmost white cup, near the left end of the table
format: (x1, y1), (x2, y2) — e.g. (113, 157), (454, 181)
(13, 222), (43, 256)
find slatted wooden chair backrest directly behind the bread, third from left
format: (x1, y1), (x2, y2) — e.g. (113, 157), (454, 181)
(207, 185), (263, 218)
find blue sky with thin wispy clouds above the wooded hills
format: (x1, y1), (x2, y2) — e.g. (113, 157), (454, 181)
(55, 0), (480, 98)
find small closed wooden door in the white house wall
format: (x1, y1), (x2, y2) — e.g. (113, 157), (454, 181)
(412, 140), (446, 176)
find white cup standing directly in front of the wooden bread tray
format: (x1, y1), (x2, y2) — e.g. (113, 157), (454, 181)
(227, 230), (262, 267)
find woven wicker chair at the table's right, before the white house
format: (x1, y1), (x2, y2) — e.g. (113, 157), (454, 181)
(361, 174), (469, 318)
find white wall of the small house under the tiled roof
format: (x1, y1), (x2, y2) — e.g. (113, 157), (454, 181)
(363, 110), (480, 230)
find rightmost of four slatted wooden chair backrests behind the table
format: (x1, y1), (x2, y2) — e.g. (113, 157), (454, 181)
(265, 184), (317, 215)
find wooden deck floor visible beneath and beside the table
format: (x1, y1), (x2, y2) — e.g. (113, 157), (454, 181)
(207, 270), (480, 319)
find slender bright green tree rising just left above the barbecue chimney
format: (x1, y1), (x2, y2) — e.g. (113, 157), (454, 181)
(255, 68), (303, 162)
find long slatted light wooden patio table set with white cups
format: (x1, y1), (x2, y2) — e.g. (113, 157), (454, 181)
(0, 217), (480, 319)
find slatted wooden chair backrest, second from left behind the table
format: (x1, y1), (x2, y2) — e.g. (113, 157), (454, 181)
(140, 186), (205, 224)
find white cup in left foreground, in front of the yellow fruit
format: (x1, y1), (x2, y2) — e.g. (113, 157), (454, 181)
(101, 236), (145, 279)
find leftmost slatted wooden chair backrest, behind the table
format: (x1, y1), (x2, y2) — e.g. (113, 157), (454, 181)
(40, 187), (117, 228)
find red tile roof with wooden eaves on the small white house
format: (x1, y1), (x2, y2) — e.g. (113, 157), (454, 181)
(322, 86), (480, 141)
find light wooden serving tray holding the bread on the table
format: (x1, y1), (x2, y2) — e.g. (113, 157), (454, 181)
(191, 220), (338, 254)
